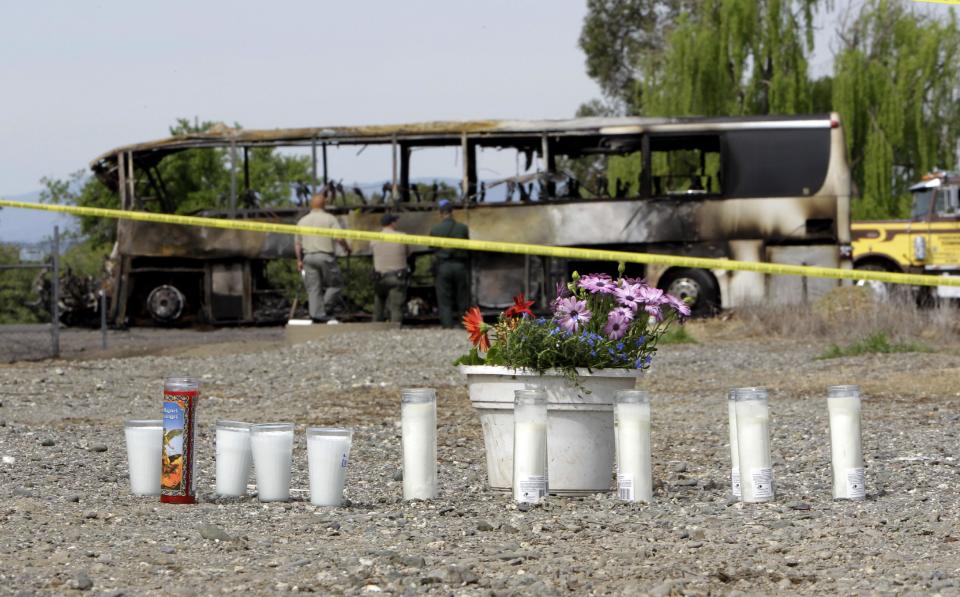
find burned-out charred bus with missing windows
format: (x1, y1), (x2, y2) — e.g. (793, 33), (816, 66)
(91, 114), (850, 325)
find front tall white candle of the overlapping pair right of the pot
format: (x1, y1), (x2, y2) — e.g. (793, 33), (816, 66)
(734, 388), (774, 502)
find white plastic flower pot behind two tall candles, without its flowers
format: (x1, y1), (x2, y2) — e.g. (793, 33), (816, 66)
(460, 365), (642, 495)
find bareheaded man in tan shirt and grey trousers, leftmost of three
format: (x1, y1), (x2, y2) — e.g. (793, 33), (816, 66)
(294, 189), (350, 323)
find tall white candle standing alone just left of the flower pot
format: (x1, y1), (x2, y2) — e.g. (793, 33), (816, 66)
(400, 388), (437, 500)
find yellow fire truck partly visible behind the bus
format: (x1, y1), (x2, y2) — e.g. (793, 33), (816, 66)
(850, 172), (960, 299)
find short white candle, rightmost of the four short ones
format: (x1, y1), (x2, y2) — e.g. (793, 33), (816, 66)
(307, 427), (353, 506)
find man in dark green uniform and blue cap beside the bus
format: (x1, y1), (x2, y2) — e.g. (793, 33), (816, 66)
(430, 199), (470, 328)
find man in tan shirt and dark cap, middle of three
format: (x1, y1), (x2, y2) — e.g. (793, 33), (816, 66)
(370, 214), (410, 323)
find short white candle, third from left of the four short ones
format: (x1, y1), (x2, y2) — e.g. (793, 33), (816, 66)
(250, 423), (293, 502)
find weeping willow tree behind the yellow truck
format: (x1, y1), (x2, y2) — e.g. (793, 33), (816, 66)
(833, 0), (960, 218)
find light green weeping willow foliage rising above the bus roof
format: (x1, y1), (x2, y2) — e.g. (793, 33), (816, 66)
(632, 0), (822, 116)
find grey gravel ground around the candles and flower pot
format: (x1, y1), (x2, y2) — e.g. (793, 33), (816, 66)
(0, 329), (960, 595)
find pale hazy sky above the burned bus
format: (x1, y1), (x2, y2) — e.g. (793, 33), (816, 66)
(0, 0), (956, 195)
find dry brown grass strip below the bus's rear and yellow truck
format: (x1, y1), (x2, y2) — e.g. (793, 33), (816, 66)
(692, 286), (960, 349)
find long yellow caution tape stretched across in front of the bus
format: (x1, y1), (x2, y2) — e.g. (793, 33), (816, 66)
(0, 199), (960, 286)
